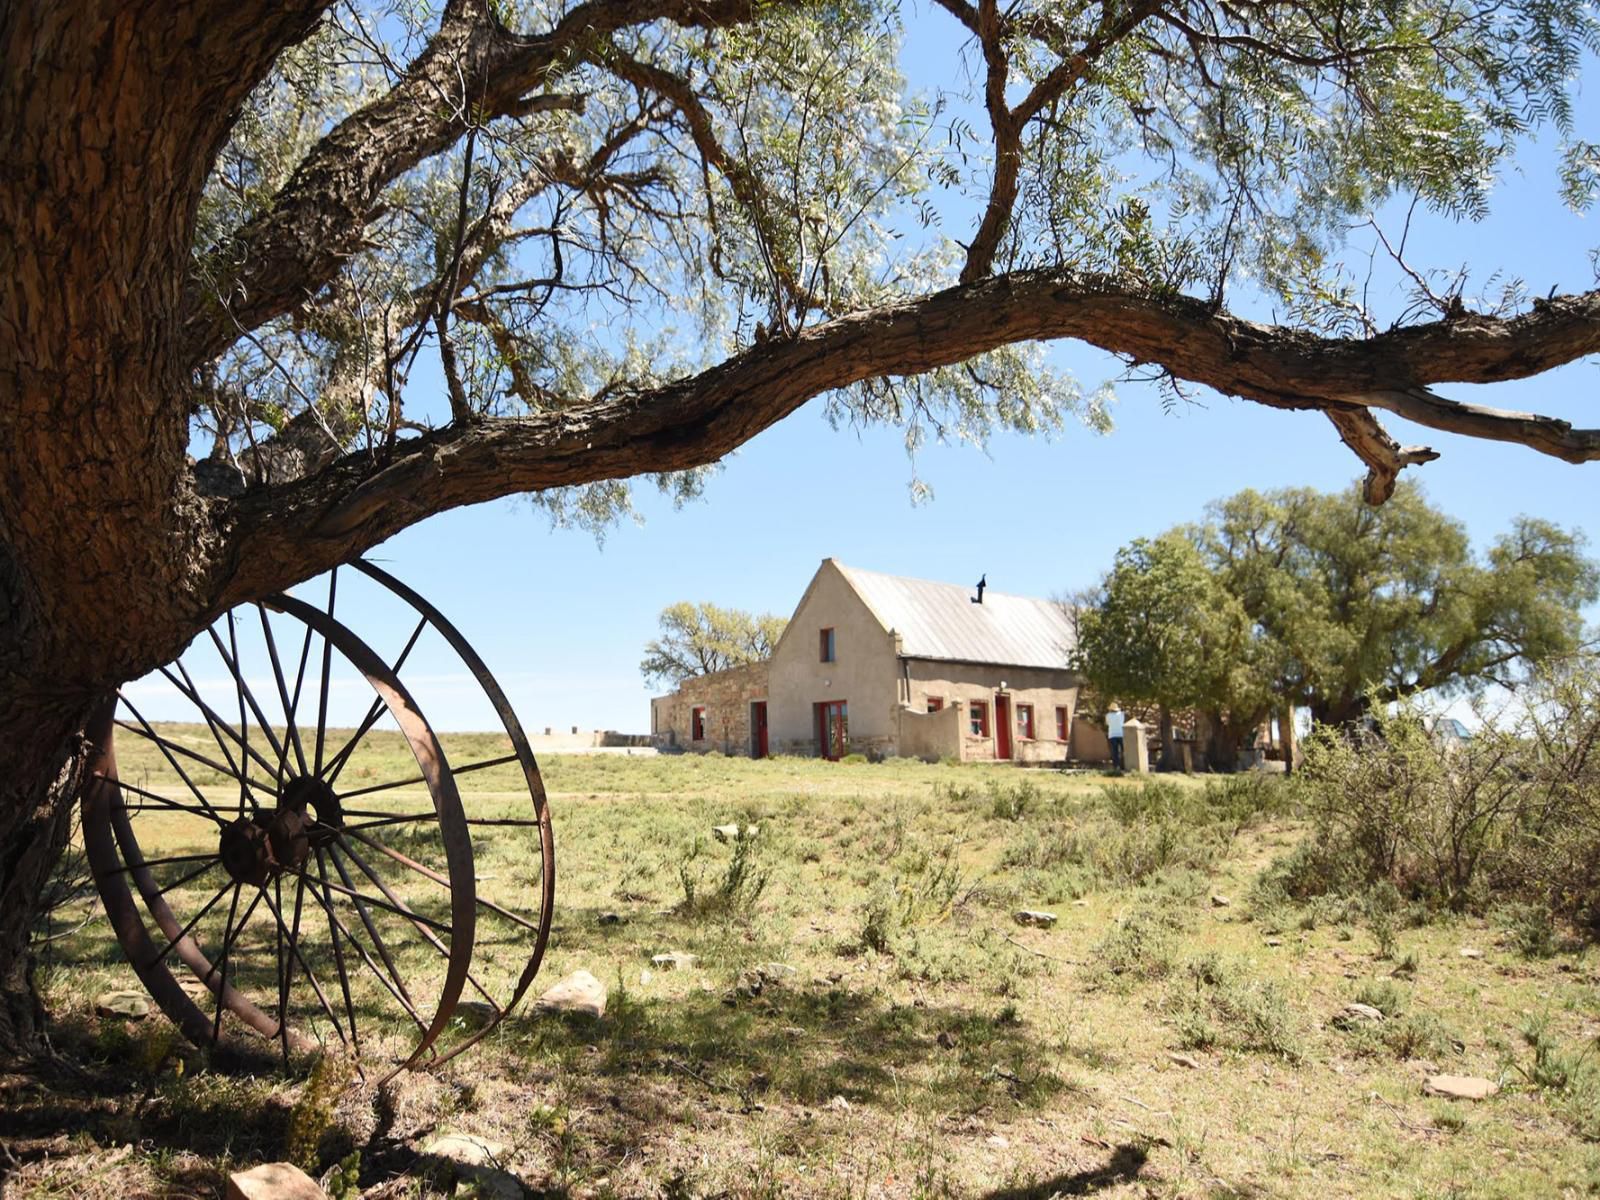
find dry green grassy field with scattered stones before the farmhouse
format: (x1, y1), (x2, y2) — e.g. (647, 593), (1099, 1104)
(12, 728), (1600, 1200)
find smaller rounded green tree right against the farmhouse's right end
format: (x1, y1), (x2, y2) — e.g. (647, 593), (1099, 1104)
(1074, 530), (1272, 758)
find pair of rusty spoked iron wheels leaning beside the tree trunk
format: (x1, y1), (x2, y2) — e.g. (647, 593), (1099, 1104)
(83, 562), (555, 1070)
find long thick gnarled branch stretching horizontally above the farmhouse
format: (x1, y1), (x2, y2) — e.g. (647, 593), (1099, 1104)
(219, 270), (1600, 605)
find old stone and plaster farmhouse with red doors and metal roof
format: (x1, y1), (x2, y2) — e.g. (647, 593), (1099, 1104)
(650, 558), (1080, 762)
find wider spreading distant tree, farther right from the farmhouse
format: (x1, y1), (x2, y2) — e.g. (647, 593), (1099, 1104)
(1190, 485), (1600, 723)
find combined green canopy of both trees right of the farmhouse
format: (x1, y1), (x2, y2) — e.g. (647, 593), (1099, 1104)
(1078, 485), (1600, 734)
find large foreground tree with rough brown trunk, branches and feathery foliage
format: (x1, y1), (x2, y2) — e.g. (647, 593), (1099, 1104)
(0, 0), (1600, 1040)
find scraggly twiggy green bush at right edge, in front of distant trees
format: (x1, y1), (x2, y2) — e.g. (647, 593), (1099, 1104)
(1259, 659), (1600, 928)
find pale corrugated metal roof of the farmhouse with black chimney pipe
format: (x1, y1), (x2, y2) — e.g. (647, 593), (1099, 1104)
(834, 560), (1074, 669)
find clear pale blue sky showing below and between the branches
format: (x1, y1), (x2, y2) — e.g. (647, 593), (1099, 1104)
(150, 14), (1600, 731)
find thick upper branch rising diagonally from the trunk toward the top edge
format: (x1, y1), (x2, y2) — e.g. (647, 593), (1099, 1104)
(184, 0), (752, 365)
